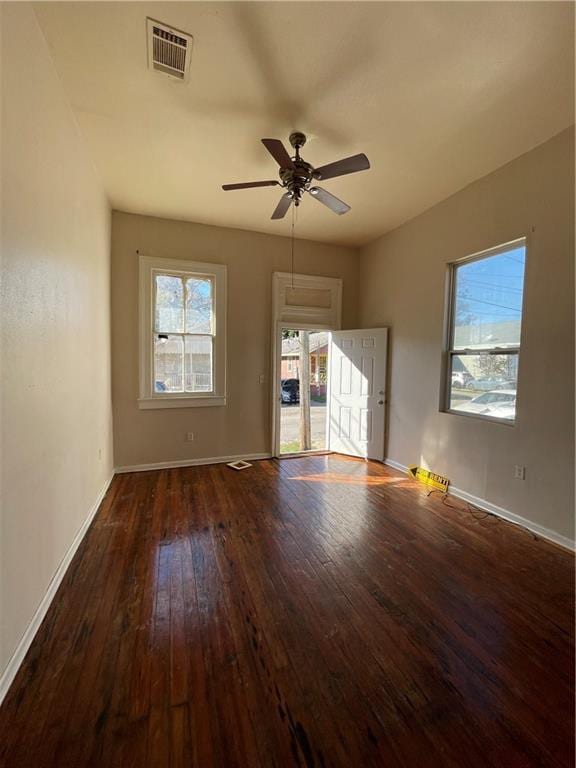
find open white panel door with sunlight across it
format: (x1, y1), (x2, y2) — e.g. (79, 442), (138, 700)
(327, 328), (388, 461)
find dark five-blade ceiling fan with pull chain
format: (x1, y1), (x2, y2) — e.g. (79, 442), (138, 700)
(222, 131), (370, 219)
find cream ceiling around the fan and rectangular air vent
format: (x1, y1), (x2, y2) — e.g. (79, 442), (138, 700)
(35, 2), (574, 245)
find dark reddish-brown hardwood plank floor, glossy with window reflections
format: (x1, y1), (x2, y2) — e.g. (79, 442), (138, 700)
(0, 456), (574, 768)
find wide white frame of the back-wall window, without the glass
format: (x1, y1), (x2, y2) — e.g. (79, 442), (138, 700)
(138, 256), (226, 409)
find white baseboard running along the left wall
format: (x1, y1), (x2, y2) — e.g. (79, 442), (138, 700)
(0, 473), (114, 704)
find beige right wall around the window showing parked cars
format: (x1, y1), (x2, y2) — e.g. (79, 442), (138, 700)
(359, 131), (574, 538)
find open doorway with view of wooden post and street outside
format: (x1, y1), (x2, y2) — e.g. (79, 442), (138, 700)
(278, 328), (330, 456)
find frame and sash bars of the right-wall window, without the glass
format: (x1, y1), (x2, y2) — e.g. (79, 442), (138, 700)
(440, 237), (528, 427)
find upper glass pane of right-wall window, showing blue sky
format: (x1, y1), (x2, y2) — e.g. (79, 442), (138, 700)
(453, 246), (526, 349)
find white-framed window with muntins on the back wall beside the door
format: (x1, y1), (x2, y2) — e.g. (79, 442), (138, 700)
(139, 256), (226, 408)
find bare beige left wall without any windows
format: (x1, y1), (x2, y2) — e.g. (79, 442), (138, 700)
(0, 3), (112, 671)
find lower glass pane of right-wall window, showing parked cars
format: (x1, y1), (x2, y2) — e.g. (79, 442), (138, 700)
(449, 354), (518, 421)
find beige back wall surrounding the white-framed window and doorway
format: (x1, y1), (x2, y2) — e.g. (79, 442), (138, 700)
(112, 211), (358, 467)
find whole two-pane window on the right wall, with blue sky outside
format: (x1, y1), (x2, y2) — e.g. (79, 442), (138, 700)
(444, 238), (526, 423)
